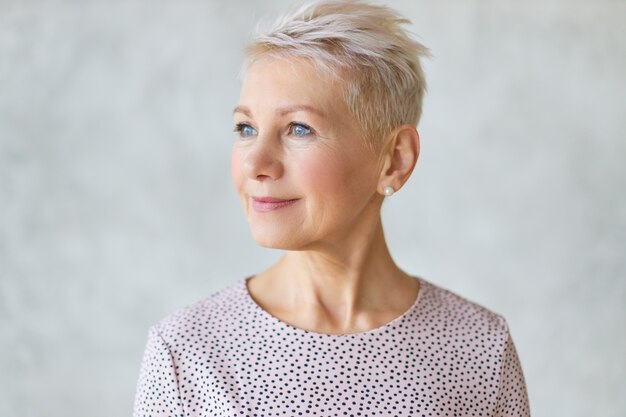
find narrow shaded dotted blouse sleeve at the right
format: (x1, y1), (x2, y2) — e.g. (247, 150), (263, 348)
(493, 320), (530, 417)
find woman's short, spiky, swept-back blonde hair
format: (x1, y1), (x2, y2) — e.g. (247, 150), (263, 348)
(242, 0), (430, 151)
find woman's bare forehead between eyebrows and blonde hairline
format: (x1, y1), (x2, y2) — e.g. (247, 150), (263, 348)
(239, 57), (344, 111)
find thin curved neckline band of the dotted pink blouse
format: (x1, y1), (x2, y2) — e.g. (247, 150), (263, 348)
(240, 275), (427, 338)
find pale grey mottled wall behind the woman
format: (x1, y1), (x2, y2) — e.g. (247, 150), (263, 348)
(0, 0), (626, 417)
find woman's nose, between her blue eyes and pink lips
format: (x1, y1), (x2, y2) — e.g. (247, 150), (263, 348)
(243, 135), (284, 181)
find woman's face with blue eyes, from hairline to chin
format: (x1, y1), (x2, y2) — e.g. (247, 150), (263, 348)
(231, 58), (382, 250)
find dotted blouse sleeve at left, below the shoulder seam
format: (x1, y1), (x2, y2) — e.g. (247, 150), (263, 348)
(133, 326), (184, 417)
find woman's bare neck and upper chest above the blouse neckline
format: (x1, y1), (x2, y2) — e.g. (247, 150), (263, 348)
(248, 216), (419, 334)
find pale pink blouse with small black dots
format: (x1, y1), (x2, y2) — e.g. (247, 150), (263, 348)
(133, 277), (530, 417)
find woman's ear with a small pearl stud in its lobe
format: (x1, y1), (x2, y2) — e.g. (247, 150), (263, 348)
(378, 124), (420, 195)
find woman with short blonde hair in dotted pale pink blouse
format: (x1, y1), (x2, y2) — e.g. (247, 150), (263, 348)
(134, 1), (529, 417)
